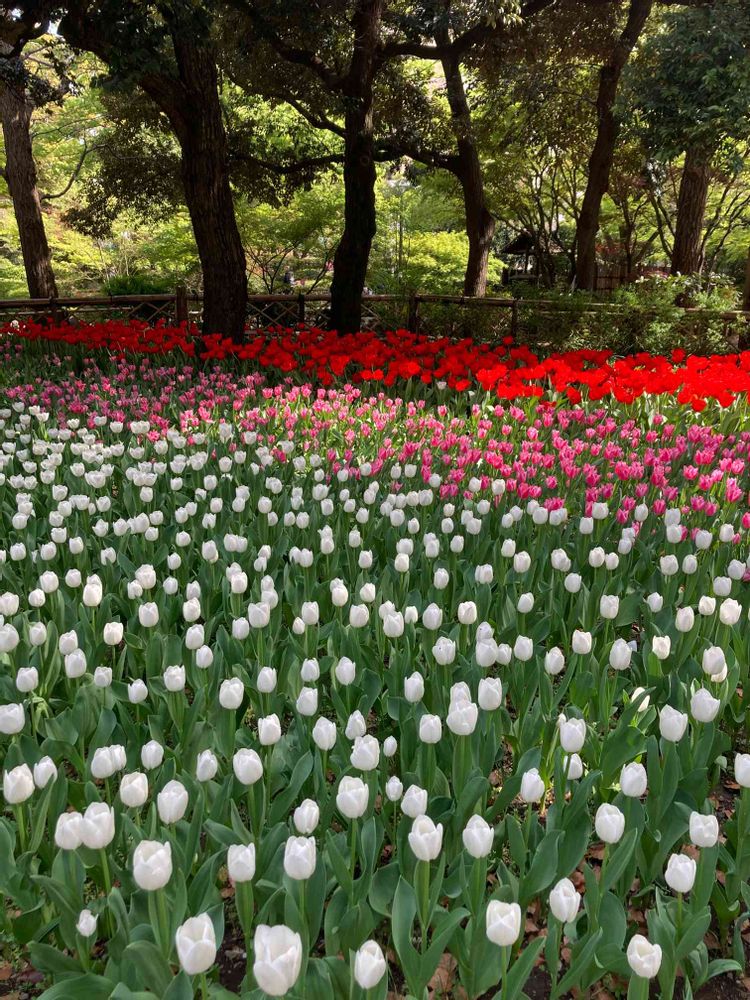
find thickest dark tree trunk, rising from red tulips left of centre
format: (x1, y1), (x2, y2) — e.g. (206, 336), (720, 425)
(167, 37), (247, 340)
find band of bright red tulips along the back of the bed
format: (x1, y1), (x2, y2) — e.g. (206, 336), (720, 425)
(1, 320), (750, 410)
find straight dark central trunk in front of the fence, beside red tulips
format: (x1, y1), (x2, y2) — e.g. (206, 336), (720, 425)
(331, 0), (385, 333)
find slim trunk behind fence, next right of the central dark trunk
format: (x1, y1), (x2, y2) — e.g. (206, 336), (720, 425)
(444, 48), (495, 295)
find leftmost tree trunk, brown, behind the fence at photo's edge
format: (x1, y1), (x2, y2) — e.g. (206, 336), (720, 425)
(0, 79), (57, 299)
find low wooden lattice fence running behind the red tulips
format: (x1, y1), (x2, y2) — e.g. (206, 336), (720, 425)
(0, 286), (750, 347)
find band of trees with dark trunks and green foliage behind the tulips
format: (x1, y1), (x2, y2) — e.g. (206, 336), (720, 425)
(0, 0), (750, 336)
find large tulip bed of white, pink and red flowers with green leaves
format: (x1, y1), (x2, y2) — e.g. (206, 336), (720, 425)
(0, 340), (750, 1000)
